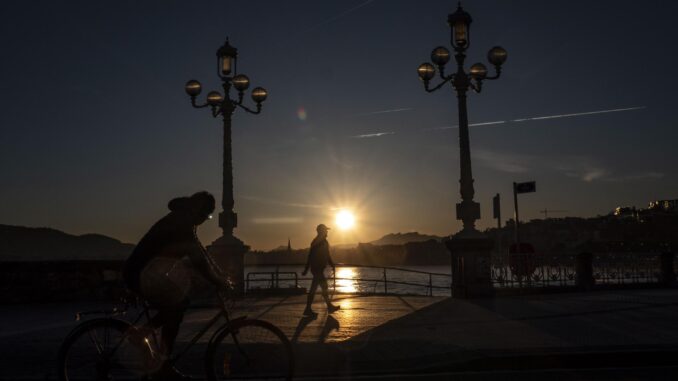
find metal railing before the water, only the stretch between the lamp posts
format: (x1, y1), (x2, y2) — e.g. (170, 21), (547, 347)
(245, 263), (451, 296)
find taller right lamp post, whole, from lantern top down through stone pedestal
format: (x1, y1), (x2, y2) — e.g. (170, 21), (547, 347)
(417, 2), (507, 296)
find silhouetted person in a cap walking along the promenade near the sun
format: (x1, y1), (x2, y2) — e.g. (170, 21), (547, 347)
(301, 224), (339, 317)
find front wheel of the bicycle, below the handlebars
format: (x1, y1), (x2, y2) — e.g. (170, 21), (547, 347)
(205, 319), (294, 381)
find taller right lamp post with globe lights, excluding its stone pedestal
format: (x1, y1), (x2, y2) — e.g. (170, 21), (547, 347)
(417, 3), (506, 235)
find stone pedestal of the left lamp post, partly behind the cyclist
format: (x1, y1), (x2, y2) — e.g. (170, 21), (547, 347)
(207, 236), (249, 295)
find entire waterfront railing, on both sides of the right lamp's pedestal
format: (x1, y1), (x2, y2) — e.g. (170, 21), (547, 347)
(245, 242), (678, 296)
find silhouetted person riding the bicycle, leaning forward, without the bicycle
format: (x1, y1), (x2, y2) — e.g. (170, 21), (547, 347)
(123, 192), (227, 380)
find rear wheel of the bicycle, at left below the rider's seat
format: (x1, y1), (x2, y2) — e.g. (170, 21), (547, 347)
(58, 318), (152, 381)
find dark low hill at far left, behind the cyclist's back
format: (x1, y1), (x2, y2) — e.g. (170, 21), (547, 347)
(0, 224), (134, 261)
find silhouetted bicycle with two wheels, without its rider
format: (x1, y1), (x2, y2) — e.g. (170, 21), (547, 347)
(58, 286), (294, 381)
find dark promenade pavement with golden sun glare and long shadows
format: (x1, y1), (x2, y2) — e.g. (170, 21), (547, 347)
(0, 289), (678, 380)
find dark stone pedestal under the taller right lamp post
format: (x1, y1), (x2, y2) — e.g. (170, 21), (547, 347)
(445, 233), (494, 298)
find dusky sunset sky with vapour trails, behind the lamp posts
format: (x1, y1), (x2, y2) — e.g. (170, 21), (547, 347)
(0, 0), (678, 249)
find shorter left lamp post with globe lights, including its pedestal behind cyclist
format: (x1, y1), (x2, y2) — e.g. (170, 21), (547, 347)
(185, 38), (268, 291)
